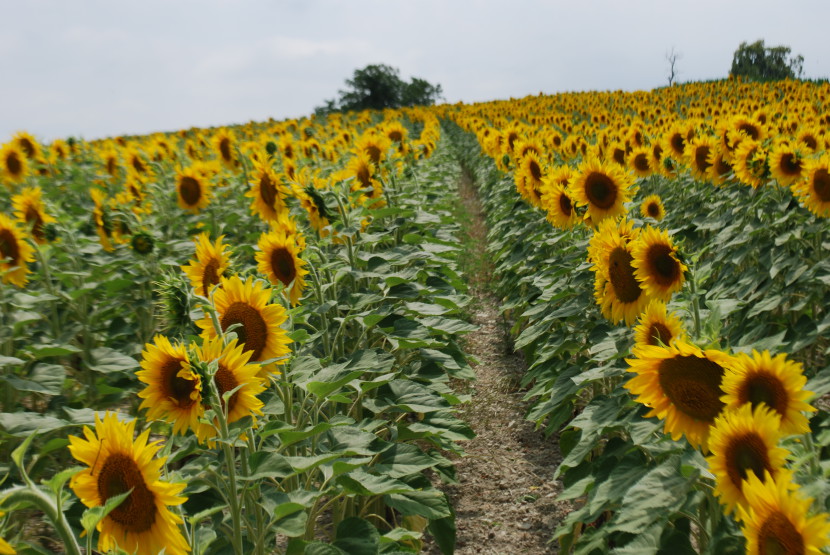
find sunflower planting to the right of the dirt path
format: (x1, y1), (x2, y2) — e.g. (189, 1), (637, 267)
(448, 76), (830, 553)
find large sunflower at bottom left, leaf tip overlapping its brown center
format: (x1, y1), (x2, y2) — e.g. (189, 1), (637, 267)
(69, 412), (190, 555)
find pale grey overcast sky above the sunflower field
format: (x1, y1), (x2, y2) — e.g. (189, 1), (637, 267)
(0, 0), (830, 143)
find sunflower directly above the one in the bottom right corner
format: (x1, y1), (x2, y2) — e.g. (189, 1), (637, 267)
(706, 405), (789, 514)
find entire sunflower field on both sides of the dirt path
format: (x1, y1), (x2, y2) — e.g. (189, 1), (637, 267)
(0, 79), (830, 555)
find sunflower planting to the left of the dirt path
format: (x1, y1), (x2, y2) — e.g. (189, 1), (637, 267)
(0, 105), (473, 554)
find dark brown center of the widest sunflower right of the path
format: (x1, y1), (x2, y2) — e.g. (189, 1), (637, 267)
(657, 355), (723, 422)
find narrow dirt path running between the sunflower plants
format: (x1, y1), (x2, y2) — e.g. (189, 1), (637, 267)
(427, 175), (570, 555)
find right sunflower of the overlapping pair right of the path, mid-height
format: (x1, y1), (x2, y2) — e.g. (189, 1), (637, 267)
(631, 226), (687, 302)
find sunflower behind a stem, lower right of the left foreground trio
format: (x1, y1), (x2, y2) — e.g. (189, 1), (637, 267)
(195, 337), (265, 443)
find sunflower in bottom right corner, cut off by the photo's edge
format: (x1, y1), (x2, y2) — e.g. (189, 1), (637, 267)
(738, 472), (830, 555)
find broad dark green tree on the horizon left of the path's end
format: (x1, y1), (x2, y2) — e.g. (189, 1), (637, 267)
(315, 64), (442, 114)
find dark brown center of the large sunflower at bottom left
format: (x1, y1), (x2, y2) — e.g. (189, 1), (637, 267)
(98, 453), (156, 533)
